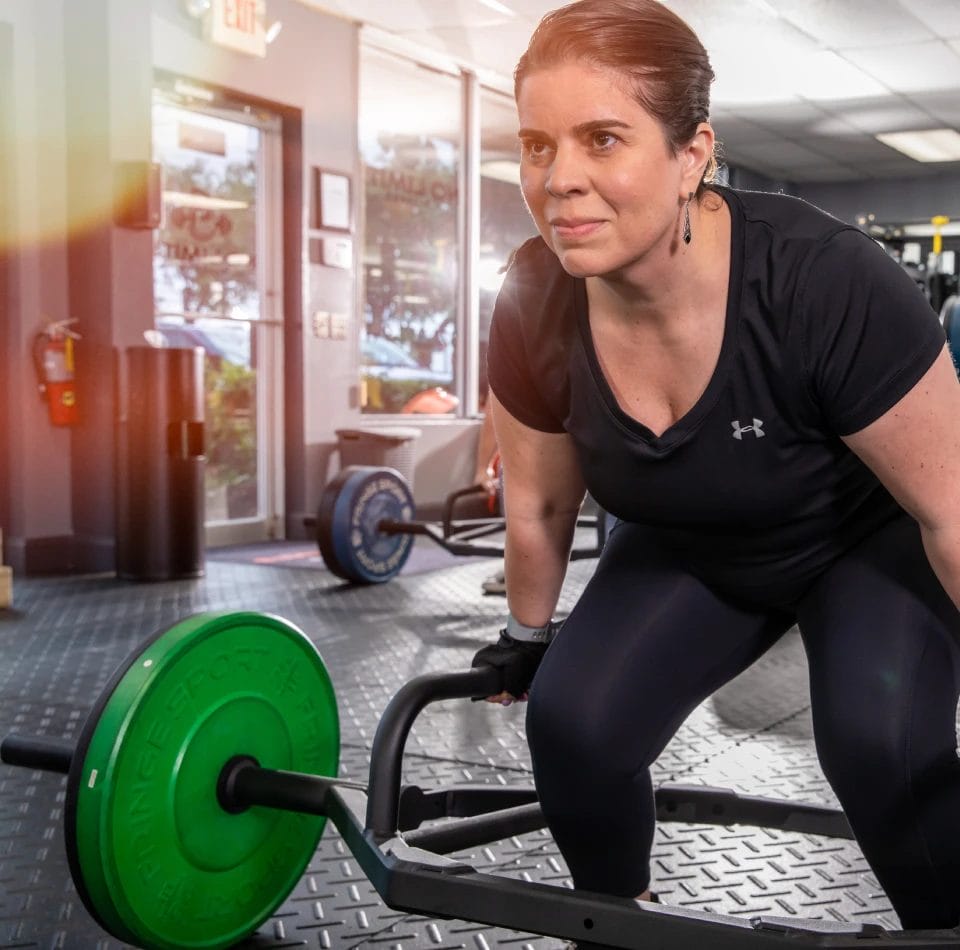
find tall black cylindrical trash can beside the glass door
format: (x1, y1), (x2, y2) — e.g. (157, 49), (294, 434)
(117, 346), (206, 581)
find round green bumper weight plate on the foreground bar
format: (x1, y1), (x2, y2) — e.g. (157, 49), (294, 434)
(65, 613), (339, 948)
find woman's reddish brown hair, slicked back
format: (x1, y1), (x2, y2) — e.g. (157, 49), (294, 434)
(514, 0), (717, 188)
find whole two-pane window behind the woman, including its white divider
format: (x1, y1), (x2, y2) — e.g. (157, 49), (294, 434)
(360, 45), (536, 414)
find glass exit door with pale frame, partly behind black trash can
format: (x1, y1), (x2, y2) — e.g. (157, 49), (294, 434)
(152, 90), (283, 546)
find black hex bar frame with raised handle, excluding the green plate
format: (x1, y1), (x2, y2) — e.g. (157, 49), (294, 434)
(242, 668), (960, 950)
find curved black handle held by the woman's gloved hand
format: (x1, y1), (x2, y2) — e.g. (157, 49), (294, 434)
(366, 666), (501, 838)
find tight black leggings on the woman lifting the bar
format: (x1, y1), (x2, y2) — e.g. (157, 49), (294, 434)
(527, 517), (960, 929)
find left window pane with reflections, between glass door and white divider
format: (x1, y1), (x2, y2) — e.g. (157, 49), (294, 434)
(360, 47), (460, 413)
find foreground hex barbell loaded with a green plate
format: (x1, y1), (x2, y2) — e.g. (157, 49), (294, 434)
(0, 612), (960, 950)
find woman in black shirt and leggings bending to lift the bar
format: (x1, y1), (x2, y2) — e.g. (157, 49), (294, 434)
(474, 0), (960, 928)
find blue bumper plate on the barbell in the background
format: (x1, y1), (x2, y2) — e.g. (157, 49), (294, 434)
(321, 465), (414, 584)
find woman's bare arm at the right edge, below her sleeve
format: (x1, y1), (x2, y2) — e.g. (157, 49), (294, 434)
(843, 348), (960, 609)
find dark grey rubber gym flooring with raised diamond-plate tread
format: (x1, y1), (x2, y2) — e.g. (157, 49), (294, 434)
(0, 539), (916, 950)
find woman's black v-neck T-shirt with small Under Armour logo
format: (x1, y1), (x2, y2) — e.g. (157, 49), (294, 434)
(487, 188), (945, 602)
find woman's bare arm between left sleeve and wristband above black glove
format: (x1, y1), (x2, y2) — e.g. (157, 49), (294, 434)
(487, 393), (586, 627)
